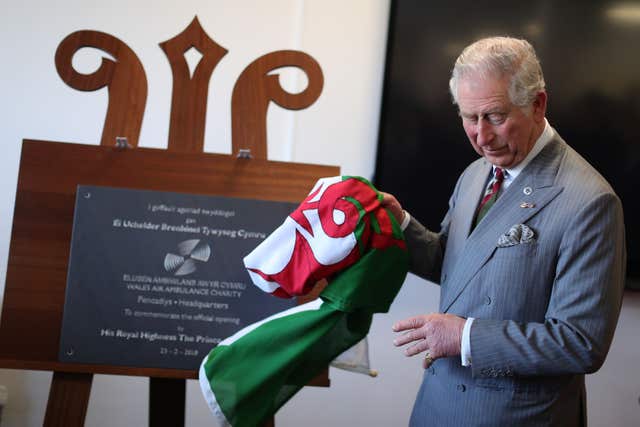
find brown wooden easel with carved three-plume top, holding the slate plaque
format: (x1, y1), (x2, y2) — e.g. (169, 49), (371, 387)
(0, 19), (339, 427)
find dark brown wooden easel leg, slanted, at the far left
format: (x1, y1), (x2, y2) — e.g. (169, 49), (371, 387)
(43, 372), (93, 427)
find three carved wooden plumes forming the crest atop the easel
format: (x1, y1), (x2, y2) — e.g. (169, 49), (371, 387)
(56, 17), (324, 159)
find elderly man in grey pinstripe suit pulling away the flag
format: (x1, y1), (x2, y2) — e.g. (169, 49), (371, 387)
(384, 37), (626, 427)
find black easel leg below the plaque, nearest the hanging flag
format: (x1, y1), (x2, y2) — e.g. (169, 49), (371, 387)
(149, 378), (186, 427)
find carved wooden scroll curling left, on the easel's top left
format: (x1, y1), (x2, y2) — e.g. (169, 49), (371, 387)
(56, 30), (147, 147)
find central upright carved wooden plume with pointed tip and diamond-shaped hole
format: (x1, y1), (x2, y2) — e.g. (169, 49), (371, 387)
(160, 17), (227, 153)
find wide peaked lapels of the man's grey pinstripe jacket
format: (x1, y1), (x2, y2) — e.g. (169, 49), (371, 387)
(440, 138), (566, 312)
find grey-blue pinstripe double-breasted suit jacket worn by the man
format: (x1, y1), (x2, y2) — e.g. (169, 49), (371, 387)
(405, 131), (626, 426)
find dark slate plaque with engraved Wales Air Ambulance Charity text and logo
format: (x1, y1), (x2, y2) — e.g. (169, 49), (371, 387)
(59, 186), (296, 369)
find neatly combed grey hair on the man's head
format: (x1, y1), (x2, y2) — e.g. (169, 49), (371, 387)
(449, 37), (545, 107)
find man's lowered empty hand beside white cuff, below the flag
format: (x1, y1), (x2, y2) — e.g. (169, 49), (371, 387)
(393, 313), (465, 369)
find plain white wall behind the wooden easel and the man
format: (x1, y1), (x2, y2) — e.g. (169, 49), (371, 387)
(0, 0), (640, 427)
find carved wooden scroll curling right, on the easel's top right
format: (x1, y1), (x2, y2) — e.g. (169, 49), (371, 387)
(231, 50), (324, 159)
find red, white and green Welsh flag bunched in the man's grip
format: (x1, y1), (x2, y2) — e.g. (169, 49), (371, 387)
(199, 176), (408, 427)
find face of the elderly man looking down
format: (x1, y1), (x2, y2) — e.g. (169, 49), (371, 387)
(458, 76), (547, 169)
